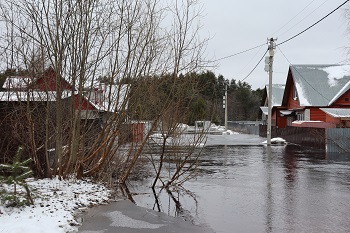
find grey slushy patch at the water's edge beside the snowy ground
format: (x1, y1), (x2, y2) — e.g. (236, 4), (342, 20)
(79, 200), (214, 233)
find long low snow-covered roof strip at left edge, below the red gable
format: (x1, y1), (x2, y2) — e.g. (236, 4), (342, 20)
(0, 91), (72, 102)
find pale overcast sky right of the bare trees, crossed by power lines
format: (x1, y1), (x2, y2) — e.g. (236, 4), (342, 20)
(201, 0), (350, 89)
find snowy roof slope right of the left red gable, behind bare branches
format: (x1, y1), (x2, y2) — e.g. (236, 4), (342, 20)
(86, 84), (130, 112)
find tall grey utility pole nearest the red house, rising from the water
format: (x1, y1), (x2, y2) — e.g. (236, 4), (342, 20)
(265, 38), (275, 145)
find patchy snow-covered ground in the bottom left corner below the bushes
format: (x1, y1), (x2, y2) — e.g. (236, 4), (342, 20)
(0, 178), (110, 233)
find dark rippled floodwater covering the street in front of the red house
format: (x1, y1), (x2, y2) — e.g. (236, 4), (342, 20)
(129, 137), (350, 233)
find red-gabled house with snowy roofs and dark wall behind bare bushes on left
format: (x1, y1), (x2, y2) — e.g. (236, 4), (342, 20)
(0, 68), (129, 162)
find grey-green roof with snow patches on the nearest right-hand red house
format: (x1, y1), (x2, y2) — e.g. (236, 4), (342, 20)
(290, 65), (350, 106)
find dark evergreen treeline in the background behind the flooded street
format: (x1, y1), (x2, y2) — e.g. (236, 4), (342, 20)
(129, 71), (263, 125)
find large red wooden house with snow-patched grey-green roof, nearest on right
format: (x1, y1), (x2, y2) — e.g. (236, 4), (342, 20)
(274, 65), (350, 128)
